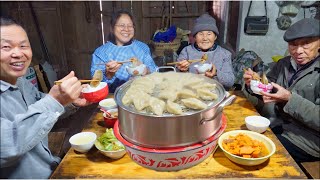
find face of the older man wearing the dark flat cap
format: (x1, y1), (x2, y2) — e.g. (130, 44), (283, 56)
(288, 37), (320, 65)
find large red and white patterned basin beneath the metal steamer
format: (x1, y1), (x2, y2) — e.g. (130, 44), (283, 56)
(113, 115), (227, 171)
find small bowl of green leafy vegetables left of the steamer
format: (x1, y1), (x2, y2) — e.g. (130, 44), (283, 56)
(94, 128), (126, 159)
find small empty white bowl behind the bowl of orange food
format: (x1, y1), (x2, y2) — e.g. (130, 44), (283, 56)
(245, 116), (270, 133)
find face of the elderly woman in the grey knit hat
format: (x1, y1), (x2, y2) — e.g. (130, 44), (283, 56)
(195, 31), (217, 51)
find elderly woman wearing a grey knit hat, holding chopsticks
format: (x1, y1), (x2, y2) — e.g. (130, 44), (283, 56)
(176, 14), (235, 88)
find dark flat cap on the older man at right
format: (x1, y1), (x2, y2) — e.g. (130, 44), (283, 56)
(283, 18), (320, 42)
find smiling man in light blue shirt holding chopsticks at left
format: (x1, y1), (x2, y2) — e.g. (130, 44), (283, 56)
(0, 17), (89, 179)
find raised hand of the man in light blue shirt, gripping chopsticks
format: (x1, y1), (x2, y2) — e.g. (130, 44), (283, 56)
(48, 71), (83, 106)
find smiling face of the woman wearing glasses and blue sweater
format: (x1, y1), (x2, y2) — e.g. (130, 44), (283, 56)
(114, 14), (134, 46)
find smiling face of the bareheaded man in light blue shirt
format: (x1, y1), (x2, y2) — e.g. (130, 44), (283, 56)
(0, 25), (32, 84)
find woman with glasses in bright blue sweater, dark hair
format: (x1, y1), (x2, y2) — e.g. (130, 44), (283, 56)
(91, 10), (157, 92)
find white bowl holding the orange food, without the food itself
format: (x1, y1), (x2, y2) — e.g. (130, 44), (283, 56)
(218, 130), (276, 166)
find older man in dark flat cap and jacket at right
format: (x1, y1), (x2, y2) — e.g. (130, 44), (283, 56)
(243, 19), (320, 162)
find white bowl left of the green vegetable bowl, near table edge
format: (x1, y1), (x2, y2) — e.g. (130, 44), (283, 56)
(69, 132), (97, 153)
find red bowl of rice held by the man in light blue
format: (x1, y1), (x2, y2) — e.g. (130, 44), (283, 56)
(82, 82), (109, 103)
